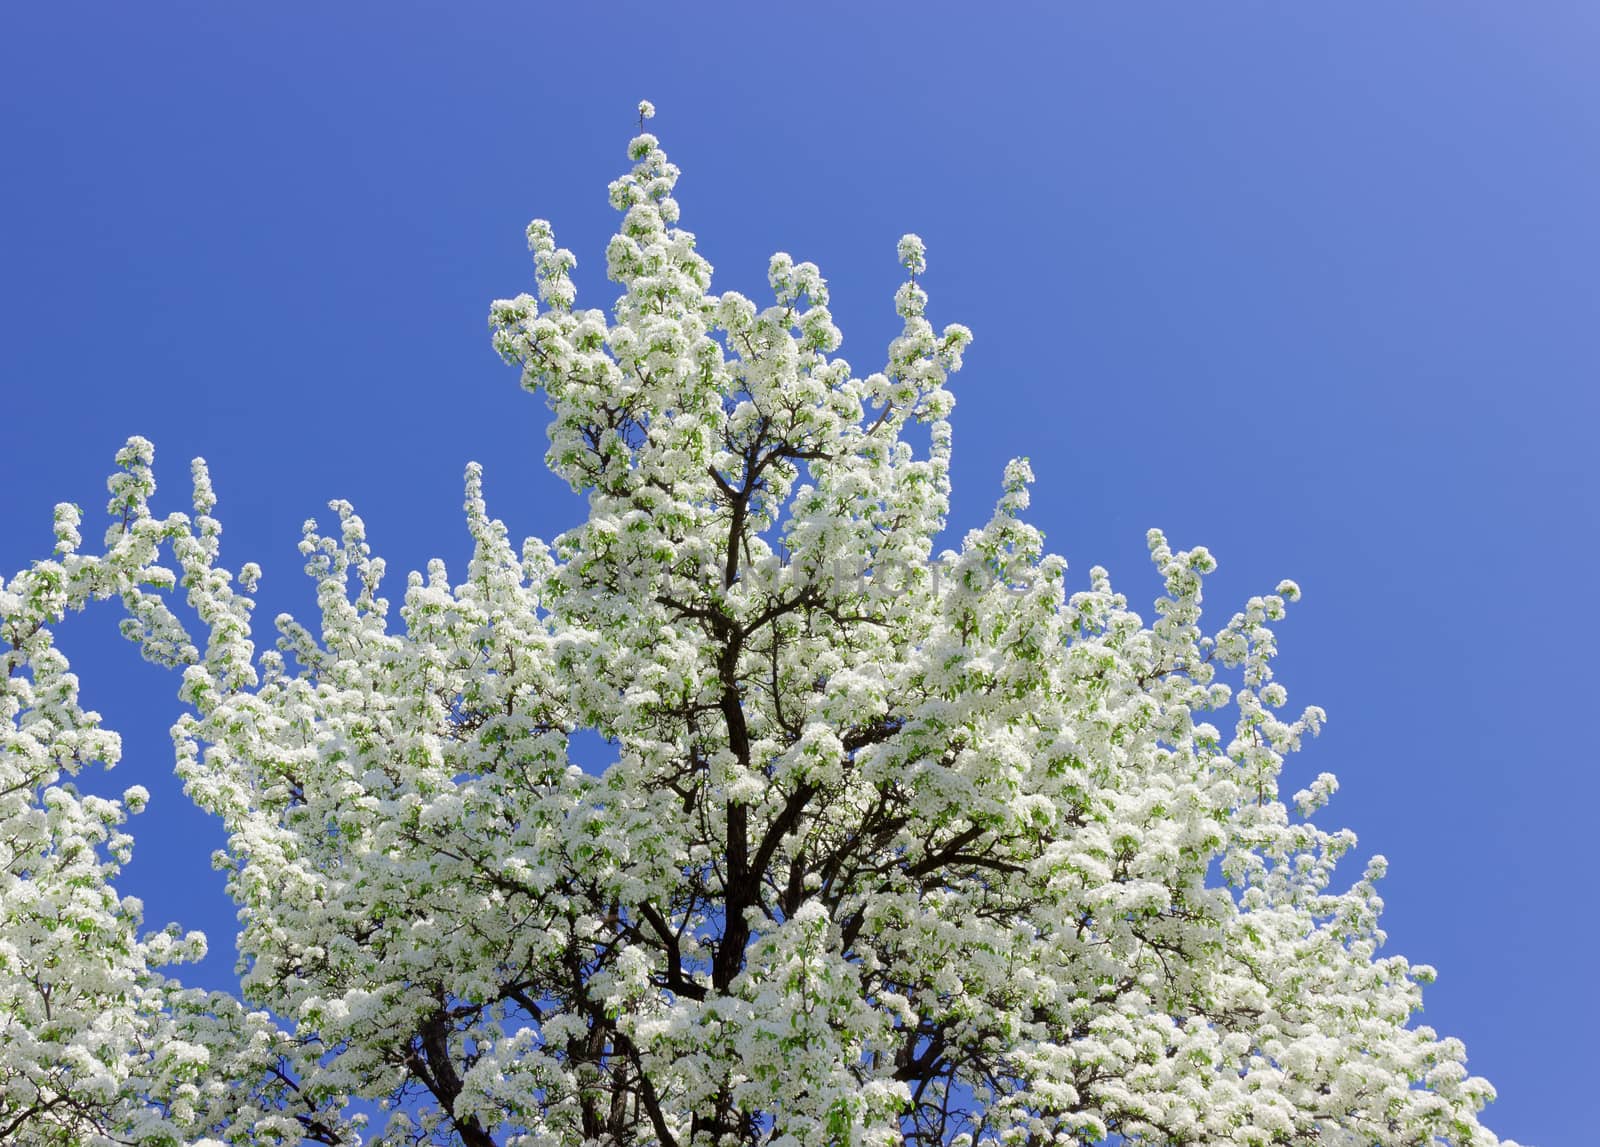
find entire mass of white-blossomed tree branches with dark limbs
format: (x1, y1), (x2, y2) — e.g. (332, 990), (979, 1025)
(0, 106), (1516, 1147)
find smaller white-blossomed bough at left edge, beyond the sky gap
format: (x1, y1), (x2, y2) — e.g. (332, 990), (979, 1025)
(0, 438), (357, 1147)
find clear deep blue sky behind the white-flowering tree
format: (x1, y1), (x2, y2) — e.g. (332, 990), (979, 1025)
(0, 0), (1600, 1147)
